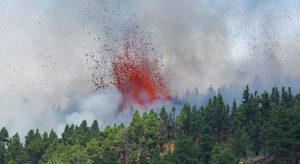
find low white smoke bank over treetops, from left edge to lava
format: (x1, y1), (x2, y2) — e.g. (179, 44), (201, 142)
(0, 87), (125, 139)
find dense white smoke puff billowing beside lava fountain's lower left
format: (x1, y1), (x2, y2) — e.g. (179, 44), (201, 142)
(57, 87), (129, 137)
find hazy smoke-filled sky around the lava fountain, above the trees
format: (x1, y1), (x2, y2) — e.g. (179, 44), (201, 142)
(0, 0), (300, 138)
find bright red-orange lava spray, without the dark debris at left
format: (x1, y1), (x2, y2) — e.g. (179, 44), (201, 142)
(112, 42), (170, 110)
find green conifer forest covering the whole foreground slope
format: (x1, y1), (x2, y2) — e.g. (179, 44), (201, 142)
(0, 86), (300, 164)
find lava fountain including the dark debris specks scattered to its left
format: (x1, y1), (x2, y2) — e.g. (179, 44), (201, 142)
(87, 25), (170, 111)
